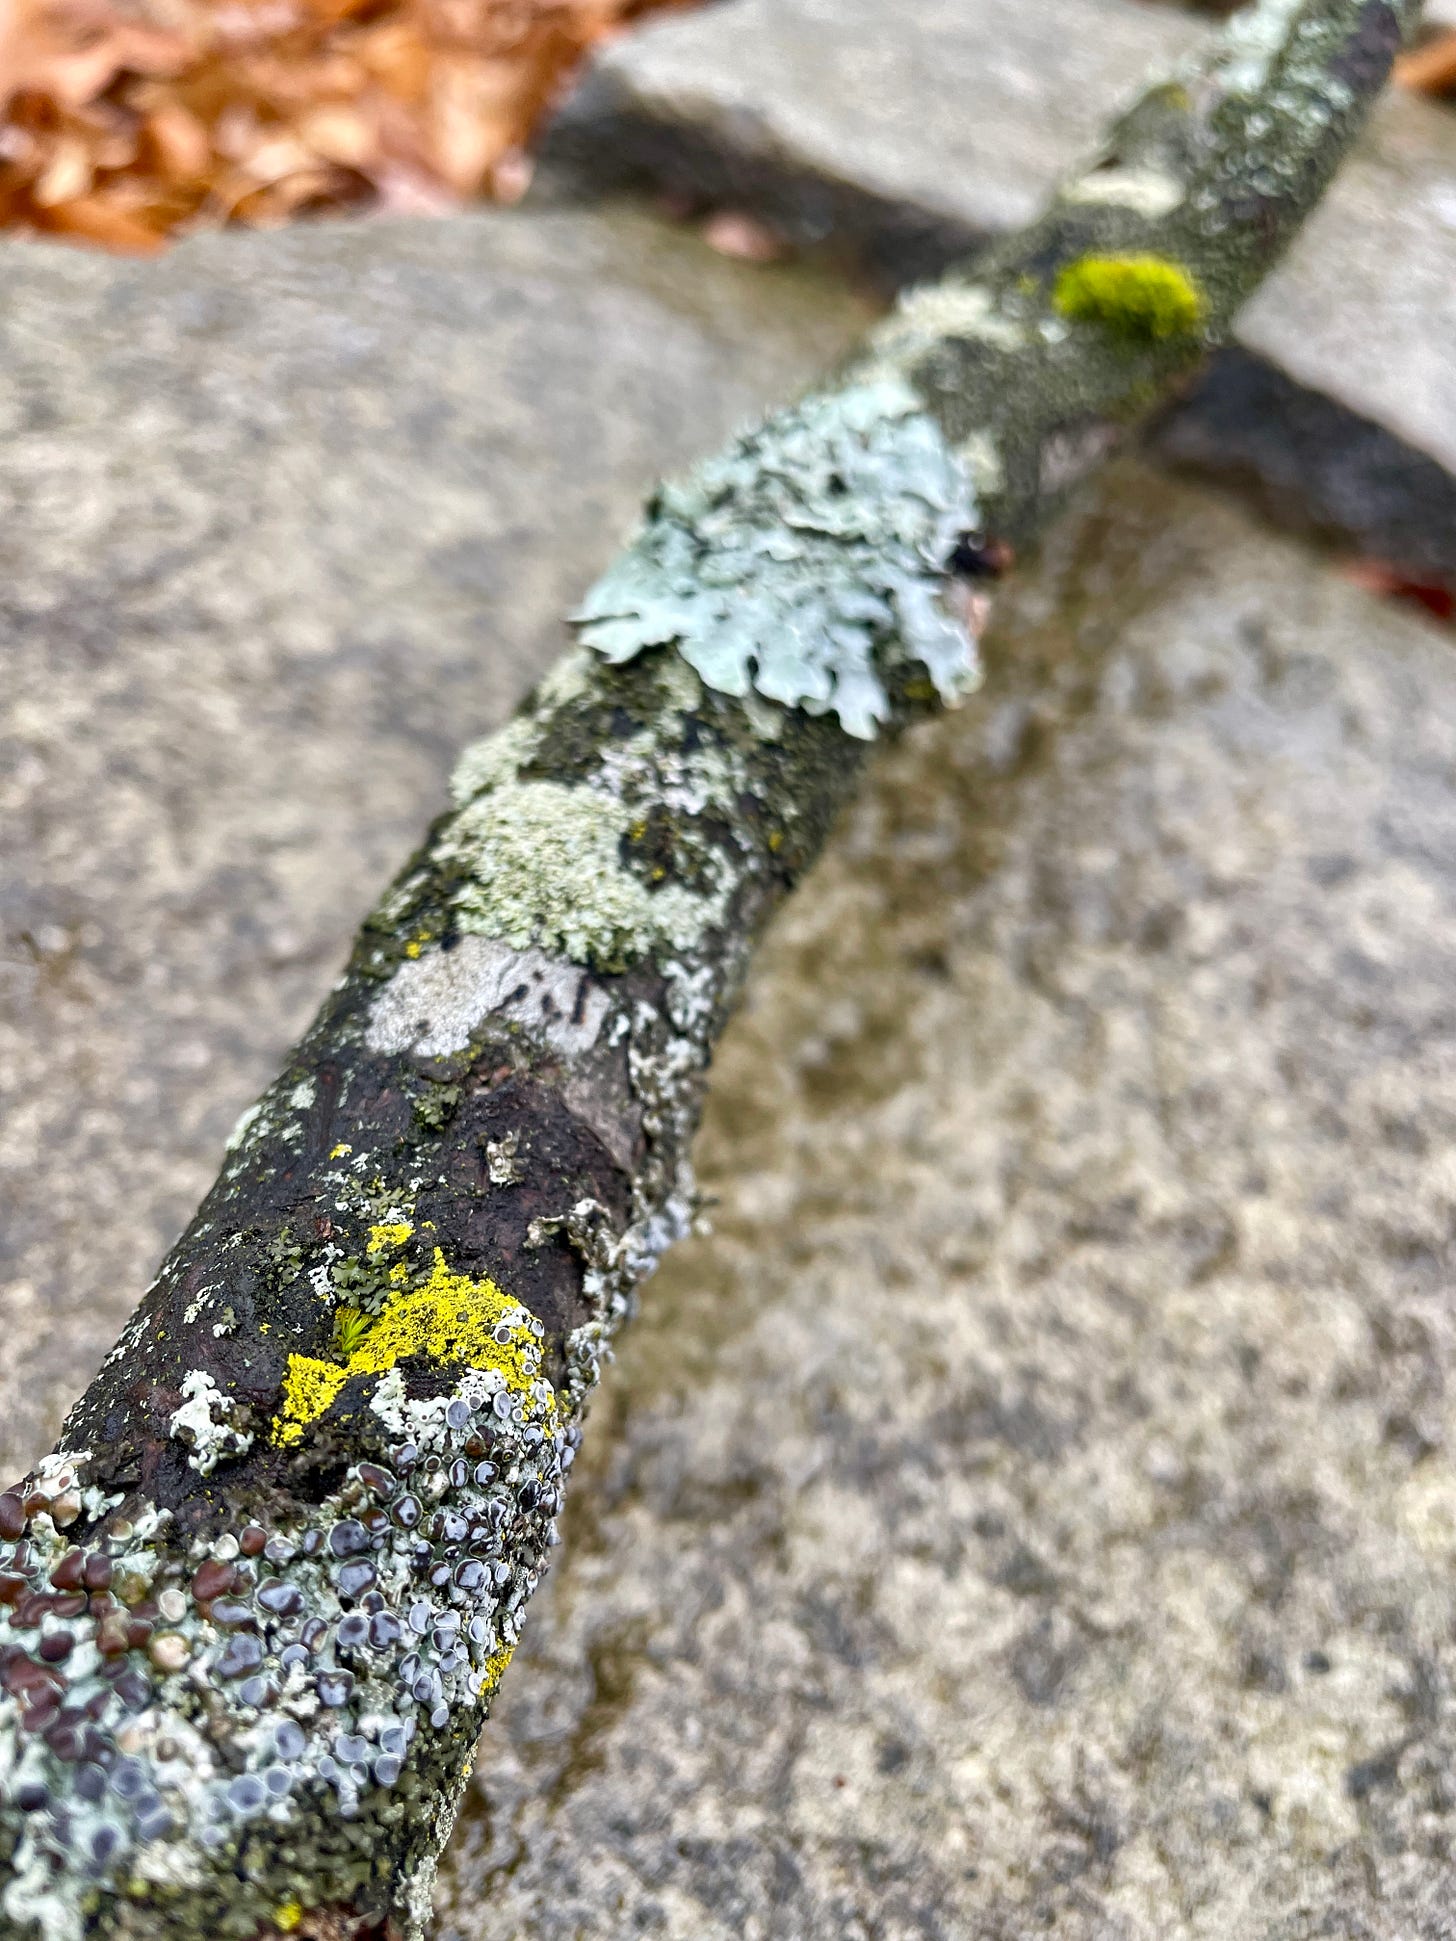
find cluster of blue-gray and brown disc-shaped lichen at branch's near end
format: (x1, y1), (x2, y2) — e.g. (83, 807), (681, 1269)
(0, 1374), (580, 1941)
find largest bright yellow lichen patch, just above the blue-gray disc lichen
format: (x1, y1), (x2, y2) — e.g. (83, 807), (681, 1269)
(272, 1248), (542, 1448)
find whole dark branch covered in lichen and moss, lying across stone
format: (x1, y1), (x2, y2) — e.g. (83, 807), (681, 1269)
(0, 0), (1415, 1941)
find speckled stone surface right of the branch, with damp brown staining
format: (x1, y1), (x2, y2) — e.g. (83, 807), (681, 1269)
(437, 470), (1456, 1941)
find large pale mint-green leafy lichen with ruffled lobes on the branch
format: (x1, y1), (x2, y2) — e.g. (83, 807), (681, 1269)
(573, 373), (978, 740)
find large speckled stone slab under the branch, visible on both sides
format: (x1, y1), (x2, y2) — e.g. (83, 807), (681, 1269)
(0, 185), (1456, 1941)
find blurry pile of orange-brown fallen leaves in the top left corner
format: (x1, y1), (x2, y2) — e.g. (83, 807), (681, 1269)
(0, 0), (689, 250)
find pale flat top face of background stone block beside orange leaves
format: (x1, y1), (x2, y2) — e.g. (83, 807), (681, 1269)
(574, 0), (1208, 235)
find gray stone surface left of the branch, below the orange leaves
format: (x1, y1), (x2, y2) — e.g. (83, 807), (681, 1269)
(0, 214), (860, 1475)
